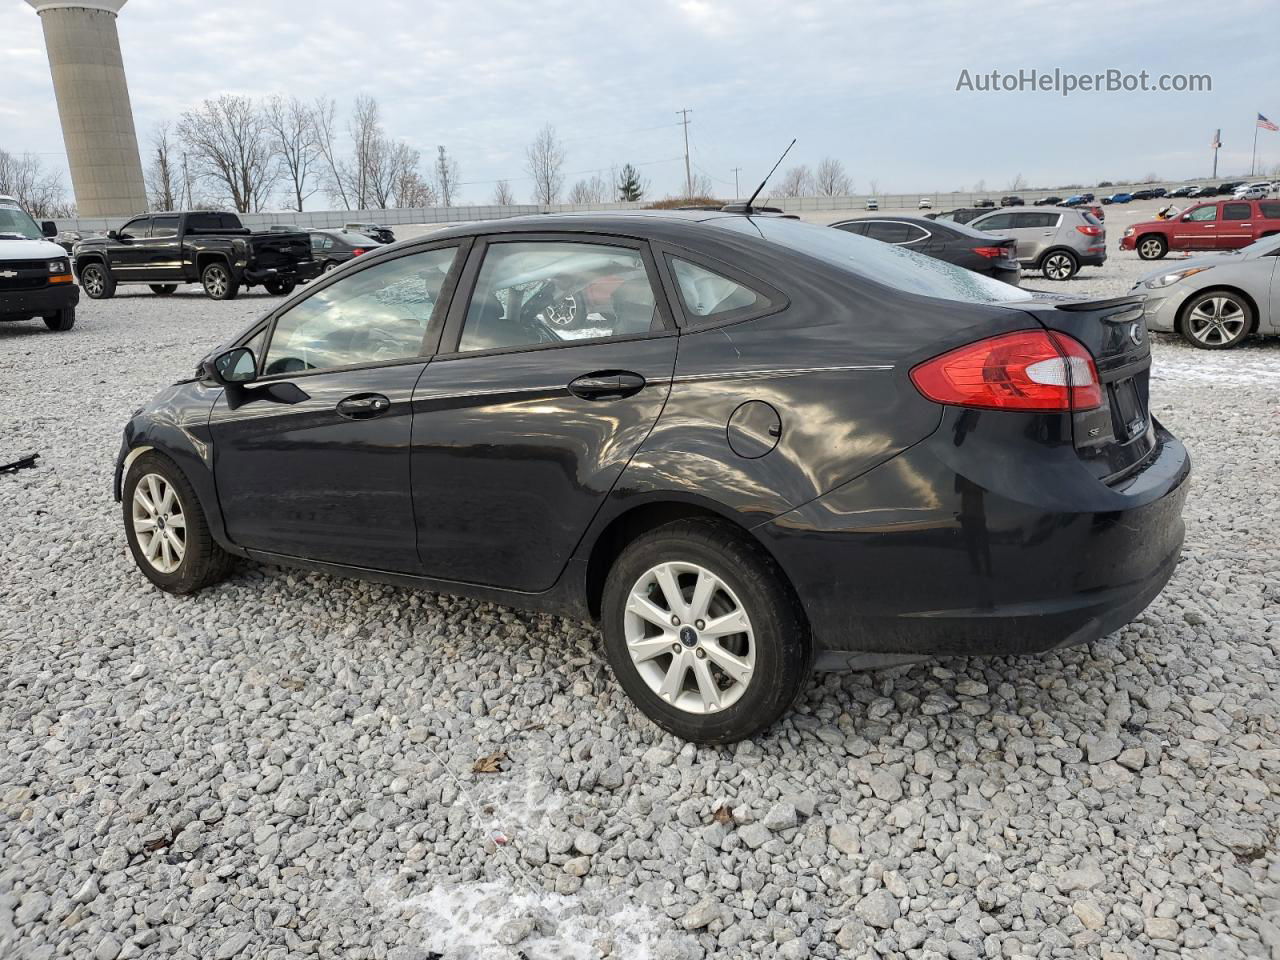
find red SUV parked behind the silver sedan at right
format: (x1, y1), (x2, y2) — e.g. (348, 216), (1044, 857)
(1120, 200), (1280, 260)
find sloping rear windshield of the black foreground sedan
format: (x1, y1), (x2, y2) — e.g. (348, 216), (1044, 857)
(712, 216), (1032, 303)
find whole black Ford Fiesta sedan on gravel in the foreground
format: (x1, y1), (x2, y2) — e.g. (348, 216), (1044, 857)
(115, 212), (1189, 742)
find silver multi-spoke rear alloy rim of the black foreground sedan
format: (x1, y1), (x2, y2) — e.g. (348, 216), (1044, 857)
(623, 562), (755, 714)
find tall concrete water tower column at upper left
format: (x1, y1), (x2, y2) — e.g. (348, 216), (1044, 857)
(27, 0), (147, 216)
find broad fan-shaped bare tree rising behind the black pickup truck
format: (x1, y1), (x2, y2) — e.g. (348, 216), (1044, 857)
(178, 93), (276, 214)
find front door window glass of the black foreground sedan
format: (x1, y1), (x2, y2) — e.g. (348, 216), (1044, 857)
(262, 247), (457, 376)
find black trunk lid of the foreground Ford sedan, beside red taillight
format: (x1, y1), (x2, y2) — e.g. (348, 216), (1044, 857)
(1016, 292), (1157, 484)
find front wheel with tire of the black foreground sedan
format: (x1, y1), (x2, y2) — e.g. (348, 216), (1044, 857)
(123, 451), (234, 594)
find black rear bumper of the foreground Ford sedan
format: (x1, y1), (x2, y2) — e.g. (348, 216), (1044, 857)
(755, 410), (1190, 657)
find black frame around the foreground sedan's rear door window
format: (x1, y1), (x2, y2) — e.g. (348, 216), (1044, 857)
(435, 232), (678, 361)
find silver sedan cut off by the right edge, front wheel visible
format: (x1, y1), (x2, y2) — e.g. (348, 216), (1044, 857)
(1134, 236), (1280, 349)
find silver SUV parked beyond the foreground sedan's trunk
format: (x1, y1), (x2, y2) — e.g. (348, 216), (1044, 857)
(969, 207), (1107, 280)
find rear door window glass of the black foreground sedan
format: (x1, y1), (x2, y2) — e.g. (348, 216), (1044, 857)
(458, 241), (662, 352)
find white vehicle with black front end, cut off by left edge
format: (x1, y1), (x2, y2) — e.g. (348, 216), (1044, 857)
(0, 196), (79, 330)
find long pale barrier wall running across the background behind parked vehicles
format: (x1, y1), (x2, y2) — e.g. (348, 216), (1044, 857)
(58, 179), (1239, 234)
